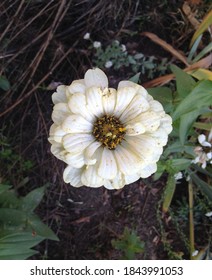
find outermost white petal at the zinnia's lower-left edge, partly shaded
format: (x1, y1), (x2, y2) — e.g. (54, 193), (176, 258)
(63, 165), (83, 187)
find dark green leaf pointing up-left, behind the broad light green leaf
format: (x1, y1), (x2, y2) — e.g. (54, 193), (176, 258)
(171, 65), (196, 99)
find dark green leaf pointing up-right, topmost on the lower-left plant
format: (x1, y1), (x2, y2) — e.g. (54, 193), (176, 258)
(22, 186), (46, 212)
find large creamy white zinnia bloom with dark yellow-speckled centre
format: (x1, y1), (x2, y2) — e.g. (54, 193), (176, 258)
(49, 68), (172, 189)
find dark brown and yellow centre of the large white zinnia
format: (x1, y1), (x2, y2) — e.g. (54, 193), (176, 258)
(93, 115), (126, 150)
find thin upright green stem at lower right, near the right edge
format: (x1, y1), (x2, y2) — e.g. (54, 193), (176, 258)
(188, 180), (195, 260)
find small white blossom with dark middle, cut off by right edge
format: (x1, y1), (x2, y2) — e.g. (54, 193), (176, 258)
(192, 129), (212, 168)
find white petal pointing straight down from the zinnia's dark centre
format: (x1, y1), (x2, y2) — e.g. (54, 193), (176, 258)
(98, 148), (117, 179)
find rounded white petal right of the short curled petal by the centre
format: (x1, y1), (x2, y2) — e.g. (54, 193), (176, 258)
(139, 111), (160, 132)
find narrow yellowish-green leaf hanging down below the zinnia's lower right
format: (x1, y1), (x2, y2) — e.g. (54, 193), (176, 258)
(162, 174), (176, 213)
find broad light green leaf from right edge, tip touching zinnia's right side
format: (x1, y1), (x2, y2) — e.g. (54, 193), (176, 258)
(172, 81), (212, 120)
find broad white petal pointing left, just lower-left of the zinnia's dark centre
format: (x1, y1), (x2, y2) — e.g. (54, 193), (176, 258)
(63, 134), (95, 154)
